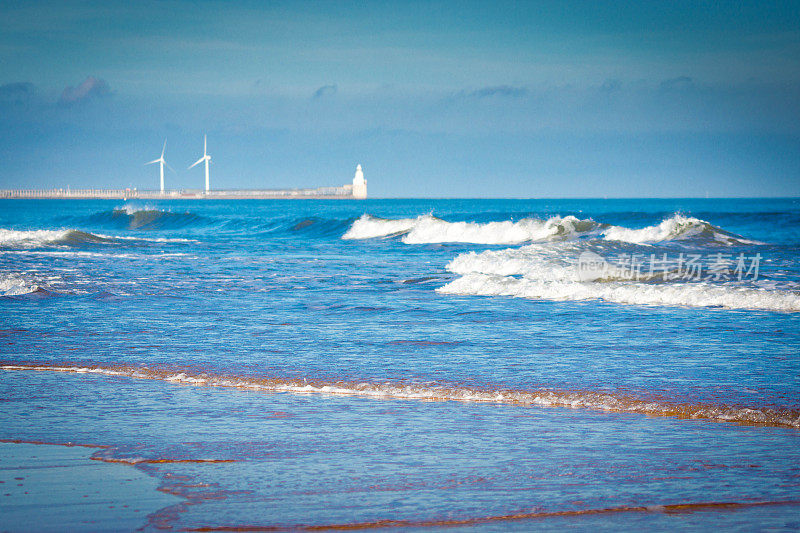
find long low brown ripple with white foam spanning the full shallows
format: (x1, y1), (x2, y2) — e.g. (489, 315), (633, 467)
(0, 362), (800, 429)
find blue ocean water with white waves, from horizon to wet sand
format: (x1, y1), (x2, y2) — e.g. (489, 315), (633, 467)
(0, 199), (800, 531)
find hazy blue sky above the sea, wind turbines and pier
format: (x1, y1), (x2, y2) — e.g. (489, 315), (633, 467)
(0, 1), (800, 197)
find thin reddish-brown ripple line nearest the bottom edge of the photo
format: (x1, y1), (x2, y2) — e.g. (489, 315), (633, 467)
(184, 500), (800, 531)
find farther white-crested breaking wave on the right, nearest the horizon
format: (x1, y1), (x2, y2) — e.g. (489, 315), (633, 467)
(342, 214), (759, 245)
